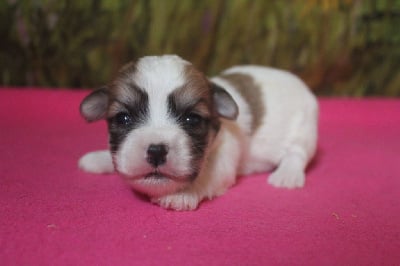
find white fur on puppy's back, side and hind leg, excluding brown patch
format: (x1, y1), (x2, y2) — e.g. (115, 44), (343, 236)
(212, 66), (318, 183)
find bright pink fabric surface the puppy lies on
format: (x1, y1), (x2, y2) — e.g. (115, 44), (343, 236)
(0, 89), (400, 265)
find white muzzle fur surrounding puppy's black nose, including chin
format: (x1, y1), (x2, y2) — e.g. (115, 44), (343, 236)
(114, 125), (191, 197)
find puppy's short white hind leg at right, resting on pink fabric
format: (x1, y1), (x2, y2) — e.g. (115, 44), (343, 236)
(268, 149), (308, 188)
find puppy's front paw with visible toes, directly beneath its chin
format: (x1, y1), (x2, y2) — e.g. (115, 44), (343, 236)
(151, 192), (200, 211)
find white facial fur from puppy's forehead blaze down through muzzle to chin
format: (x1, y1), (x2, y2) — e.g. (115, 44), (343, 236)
(114, 56), (196, 197)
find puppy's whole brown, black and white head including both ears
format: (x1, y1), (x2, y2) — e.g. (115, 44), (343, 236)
(81, 56), (238, 197)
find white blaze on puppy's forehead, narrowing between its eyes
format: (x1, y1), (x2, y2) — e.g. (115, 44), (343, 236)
(133, 55), (190, 125)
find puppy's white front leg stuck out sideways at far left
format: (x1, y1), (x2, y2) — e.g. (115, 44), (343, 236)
(78, 150), (114, 174)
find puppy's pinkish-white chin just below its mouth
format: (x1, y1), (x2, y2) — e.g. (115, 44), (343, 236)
(123, 173), (190, 197)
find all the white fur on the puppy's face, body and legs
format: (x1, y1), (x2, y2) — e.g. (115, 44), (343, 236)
(79, 56), (318, 210)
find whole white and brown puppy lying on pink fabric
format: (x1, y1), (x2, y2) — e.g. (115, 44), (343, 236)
(79, 55), (318, 210)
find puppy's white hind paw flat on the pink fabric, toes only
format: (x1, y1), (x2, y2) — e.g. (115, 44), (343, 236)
(268, 169), (306, 188)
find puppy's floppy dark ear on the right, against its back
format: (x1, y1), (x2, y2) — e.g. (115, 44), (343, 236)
(211, 82), (239, 120)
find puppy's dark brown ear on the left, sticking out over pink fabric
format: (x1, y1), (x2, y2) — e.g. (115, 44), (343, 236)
(80, 87), (109, 122)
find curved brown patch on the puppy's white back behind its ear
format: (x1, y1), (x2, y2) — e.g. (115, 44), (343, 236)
(220, 73), (265, 133)
